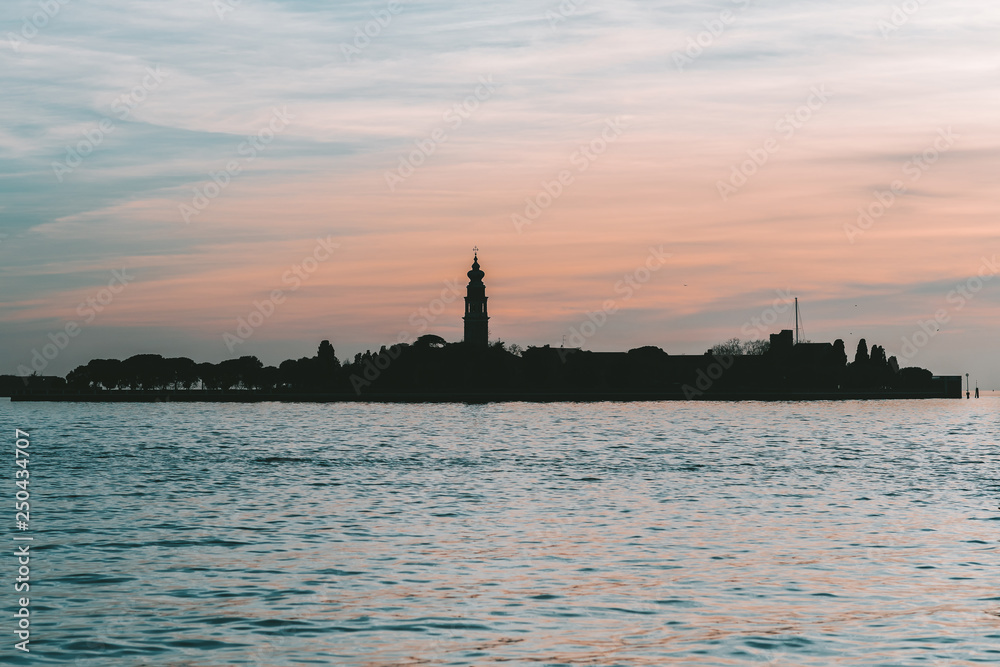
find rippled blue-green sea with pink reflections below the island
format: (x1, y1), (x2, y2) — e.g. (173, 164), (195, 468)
(0, 396), (1000, 667)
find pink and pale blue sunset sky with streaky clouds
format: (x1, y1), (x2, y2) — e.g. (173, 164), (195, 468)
(0, 0), (1000, 389)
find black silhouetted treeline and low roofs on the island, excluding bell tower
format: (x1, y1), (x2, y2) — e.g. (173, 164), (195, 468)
(7, 331), (961, 398)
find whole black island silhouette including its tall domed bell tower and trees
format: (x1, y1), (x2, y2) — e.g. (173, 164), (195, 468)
(0, 253), (962, 402)
